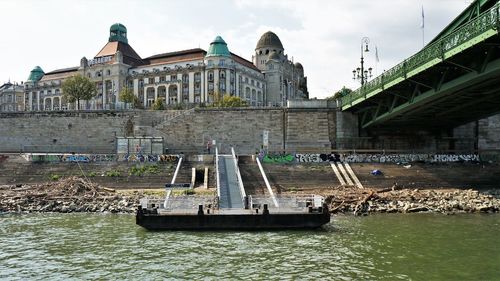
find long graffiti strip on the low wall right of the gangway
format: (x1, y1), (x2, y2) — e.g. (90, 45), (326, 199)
(259, 152), (481, 163)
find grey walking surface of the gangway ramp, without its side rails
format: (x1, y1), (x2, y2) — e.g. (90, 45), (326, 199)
(218, 155), (243, 209)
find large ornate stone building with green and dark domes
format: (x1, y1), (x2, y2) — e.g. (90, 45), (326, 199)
(24, 23), (308, 111)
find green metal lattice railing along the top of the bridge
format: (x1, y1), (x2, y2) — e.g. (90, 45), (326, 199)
(341, 3), (500, 106)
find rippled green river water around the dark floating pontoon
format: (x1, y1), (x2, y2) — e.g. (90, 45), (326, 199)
(0, 214), (500, 280)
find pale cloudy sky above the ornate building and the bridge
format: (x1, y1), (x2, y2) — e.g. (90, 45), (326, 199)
(0, 0), (471, 98)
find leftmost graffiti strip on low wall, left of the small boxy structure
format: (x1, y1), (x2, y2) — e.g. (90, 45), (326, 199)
(28, 154), (116, 163)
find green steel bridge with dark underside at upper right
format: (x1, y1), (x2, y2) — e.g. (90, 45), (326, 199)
(341, 0), (500, 129)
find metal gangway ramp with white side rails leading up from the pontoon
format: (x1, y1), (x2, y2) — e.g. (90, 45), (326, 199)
(215, 148), (246, 209)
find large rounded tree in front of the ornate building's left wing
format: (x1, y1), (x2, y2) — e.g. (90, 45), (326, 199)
(61, 74), (97, 110)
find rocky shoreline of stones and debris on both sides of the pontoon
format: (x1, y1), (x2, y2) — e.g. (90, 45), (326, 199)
(0, 177), (500, 215)
